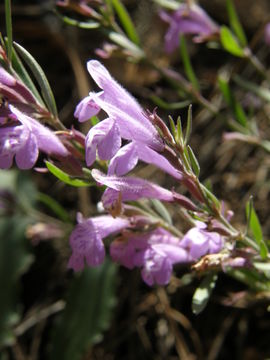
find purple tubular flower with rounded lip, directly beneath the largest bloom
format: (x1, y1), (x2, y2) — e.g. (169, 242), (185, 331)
(108, 141), (183, 180)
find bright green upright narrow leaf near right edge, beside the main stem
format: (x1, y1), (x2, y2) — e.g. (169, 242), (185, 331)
(246, 198), (268, 259)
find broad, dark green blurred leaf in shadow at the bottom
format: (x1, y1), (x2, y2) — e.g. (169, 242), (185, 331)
(49, 261), (116, 360)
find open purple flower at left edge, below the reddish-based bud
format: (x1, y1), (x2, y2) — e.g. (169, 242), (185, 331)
(0, 105), (68, 169)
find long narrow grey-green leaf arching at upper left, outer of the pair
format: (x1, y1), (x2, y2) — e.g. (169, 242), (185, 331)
(14, 42), (58, 118)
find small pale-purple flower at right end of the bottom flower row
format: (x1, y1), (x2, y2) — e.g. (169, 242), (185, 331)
(181, 221), (223, 260)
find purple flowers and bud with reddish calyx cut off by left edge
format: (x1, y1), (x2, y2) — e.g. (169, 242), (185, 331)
(0, 66), (68, 169)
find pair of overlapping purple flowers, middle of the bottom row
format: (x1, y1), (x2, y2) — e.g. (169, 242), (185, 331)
(110, 228), (191, 286)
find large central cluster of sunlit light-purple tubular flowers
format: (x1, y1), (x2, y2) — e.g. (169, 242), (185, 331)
(69, 60), (230, 285)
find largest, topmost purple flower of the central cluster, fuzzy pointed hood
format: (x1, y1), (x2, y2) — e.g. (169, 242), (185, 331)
(75, 60), (164, 164)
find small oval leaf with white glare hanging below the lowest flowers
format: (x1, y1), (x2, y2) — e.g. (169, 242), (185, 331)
(192, 274), (218, 315)
